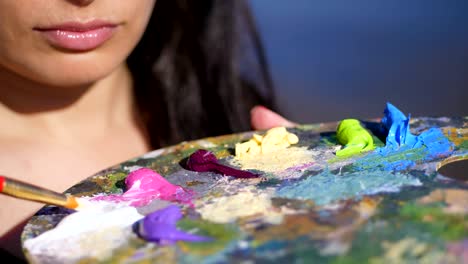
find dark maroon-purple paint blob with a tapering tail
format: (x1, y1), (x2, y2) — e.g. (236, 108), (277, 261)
(187, 149), (260, 179)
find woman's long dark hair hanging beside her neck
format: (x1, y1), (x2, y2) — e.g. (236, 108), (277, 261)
(127, 0), (274, 148)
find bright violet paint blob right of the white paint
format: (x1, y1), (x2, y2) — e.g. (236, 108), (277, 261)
(136, 205), (212, 245)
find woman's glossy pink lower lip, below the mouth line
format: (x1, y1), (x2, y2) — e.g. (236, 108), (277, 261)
(39, 26), (116, 52)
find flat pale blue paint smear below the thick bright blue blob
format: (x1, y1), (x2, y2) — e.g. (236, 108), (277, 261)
(276, 171), (422, 205)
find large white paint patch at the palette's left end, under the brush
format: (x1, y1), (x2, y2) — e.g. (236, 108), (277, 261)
(24, 201), (143, 263)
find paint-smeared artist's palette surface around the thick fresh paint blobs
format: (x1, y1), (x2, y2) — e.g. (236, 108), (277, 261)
(22, 117), (468, 263)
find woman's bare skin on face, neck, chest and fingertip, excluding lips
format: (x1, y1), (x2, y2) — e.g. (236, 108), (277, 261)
(0, 0), (292, 257)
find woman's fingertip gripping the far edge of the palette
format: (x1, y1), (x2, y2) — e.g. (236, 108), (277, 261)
(250, 106), (297, 130)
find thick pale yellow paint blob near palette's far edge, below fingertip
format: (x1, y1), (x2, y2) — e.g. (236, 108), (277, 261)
(236, 127), (299, 159)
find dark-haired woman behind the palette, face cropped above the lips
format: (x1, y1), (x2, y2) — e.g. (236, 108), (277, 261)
(0, 0), (290, 256)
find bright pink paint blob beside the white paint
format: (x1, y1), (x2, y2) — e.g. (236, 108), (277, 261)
(92, 168), (193, 207)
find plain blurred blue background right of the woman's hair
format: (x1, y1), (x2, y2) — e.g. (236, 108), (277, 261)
(250, 0), (468, 123)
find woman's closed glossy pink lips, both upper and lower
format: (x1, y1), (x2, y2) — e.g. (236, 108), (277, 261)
(35, 21), (118, 52)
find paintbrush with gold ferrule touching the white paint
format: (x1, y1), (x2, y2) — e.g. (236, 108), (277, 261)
(0, 176), (79, 209)
